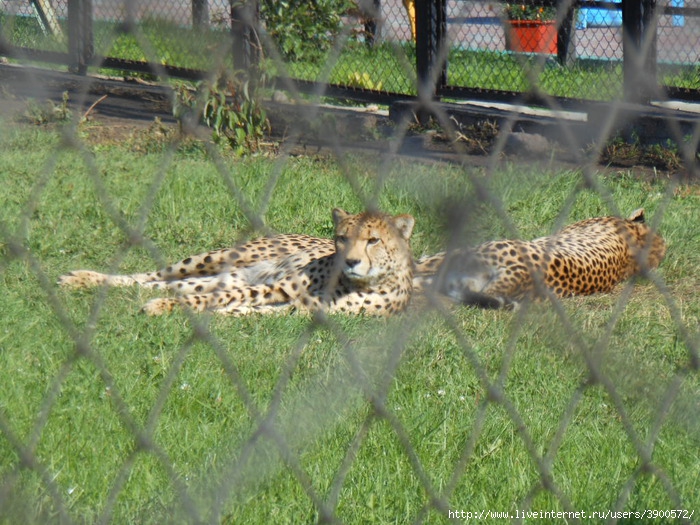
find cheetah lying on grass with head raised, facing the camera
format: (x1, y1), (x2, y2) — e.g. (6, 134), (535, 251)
(58, 208), (415, 316)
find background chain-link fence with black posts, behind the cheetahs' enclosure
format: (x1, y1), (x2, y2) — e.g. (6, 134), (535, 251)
(1, 0), (700, 102)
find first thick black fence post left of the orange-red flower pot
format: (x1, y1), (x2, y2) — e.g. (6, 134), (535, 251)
(416, 0), (447, 109)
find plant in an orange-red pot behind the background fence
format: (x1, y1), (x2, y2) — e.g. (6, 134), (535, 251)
(504, 2), (557, 55)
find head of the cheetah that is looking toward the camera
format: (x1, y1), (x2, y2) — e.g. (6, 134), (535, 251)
(333, 208), (415, 287)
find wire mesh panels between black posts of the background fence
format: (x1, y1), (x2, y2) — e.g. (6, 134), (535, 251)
(2, 0), (700, 101)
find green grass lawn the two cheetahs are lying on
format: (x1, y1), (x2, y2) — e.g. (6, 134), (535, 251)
(0, 121), (700, 523)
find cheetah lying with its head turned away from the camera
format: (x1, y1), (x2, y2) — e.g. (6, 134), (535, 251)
(417, 209), (666, 308)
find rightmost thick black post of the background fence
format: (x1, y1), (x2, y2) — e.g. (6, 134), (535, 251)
(622, 0), (658, 103)
